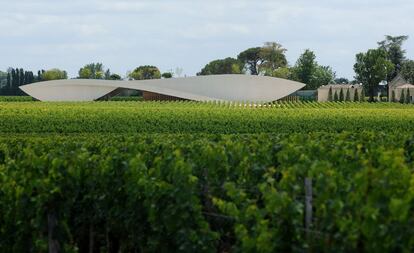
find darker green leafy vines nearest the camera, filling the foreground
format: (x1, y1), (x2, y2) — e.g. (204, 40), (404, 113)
(0, 132), (414, 252)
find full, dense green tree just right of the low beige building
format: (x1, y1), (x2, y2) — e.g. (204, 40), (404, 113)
(354, 49), (394, 102)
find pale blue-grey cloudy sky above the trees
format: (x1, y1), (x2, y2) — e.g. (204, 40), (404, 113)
(0, 0), (414, 78)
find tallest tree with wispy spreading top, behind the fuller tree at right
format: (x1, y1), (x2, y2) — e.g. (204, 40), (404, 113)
(378, 35), (408, 82)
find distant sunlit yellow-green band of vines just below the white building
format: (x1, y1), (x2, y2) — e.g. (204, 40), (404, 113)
(0, 102), (414, 134)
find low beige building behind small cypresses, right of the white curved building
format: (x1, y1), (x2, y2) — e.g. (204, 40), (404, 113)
(318, 84), (362, 102)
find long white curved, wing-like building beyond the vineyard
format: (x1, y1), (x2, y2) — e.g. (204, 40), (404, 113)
(20, 75), (305, 102)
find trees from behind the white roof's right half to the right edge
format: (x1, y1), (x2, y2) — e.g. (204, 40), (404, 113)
(197, 35), (414, 101)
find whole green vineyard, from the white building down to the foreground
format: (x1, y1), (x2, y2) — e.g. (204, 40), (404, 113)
(0, 101), (414, 252)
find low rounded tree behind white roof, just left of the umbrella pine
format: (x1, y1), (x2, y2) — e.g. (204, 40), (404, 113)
(197, 57), (243, 76)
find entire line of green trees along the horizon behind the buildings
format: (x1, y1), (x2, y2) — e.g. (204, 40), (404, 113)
(0, 35), (414, 101)
